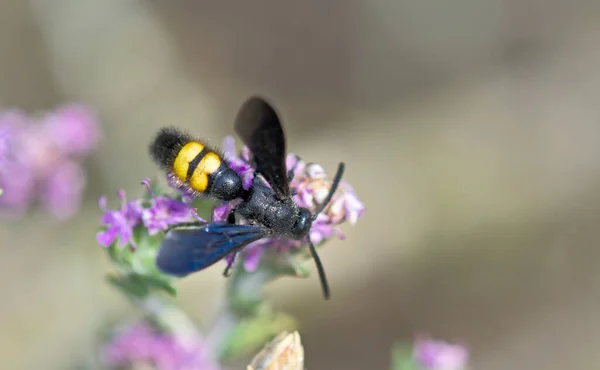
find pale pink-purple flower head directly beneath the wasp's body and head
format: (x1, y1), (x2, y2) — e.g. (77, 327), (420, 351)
(213, 137), (365, 272)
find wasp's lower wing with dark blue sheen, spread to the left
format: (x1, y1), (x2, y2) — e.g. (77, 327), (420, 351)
(156, 222), (269, 276)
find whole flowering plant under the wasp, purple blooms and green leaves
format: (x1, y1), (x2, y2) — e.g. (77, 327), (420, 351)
(96, 137), (364, 370)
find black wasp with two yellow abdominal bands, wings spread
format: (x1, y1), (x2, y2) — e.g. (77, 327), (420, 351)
(150, 96), (344, 299)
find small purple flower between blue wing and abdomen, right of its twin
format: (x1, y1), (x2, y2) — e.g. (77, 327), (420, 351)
(142, 179), (192, 235)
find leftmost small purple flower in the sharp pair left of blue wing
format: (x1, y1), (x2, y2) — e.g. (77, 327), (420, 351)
(96, 190), (143, 248)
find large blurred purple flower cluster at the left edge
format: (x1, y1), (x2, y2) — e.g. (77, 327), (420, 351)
(0, 104), (99, 219)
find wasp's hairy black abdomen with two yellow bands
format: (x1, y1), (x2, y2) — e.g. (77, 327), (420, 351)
(150, 128), (244, 201)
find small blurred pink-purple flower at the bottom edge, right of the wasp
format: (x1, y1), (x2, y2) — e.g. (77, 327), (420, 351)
(413, 338), (469, 370)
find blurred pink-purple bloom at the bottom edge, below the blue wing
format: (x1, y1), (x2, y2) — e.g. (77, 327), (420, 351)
(103, 322), (218, 370)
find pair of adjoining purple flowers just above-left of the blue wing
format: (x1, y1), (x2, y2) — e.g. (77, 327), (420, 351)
(96, 179), (193, 249)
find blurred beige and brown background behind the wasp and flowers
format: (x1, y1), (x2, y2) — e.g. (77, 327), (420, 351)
(0, 0), (600, 370)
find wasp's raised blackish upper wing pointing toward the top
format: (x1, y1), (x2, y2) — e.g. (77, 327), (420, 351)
(235, 96), (290, 199)
